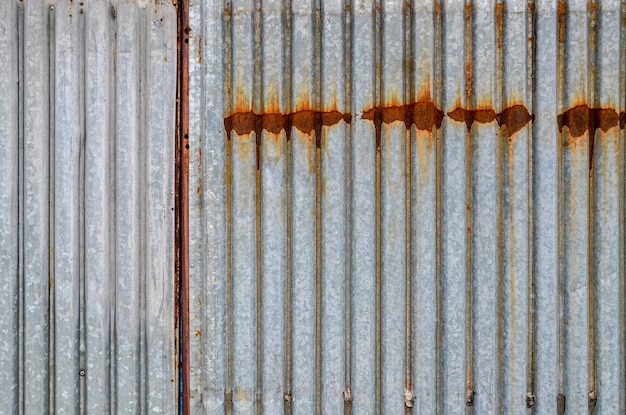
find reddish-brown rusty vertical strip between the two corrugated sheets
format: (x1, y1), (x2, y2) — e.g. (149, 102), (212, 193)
(175, 0), (190, 415)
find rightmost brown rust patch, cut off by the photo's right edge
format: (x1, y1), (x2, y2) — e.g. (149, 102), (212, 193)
(557, 105), (626, 138)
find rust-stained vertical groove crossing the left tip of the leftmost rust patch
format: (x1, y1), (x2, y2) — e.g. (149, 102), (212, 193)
(224, 0), (234, 415)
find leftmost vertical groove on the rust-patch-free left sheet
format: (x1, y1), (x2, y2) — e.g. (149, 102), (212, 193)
(17, 2), (24, 414)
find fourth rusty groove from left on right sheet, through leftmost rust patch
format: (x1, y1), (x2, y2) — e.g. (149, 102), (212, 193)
(313, 0), (324, 415)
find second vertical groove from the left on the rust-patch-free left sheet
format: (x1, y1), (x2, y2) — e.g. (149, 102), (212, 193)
(47, 1), (56, 412)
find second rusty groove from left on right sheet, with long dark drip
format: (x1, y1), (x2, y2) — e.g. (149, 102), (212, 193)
(252, 0), (265, 414)
